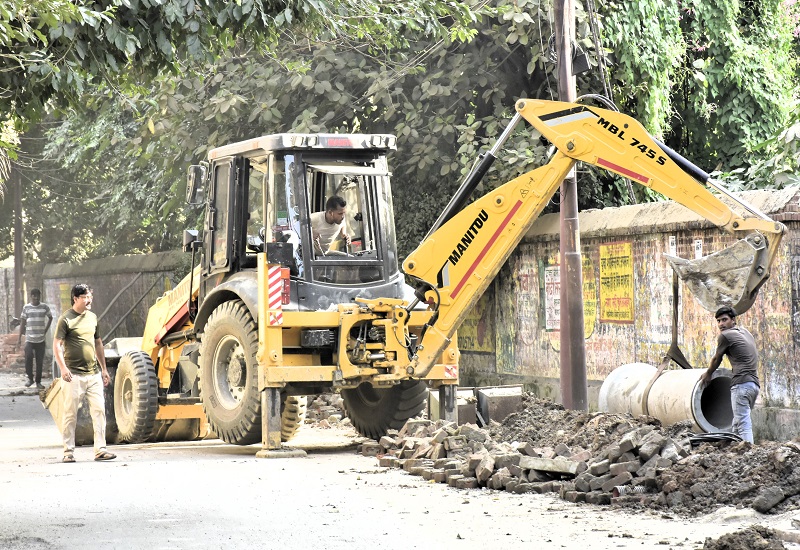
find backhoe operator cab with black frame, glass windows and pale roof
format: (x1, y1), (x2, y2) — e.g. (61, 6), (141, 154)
(190, 134), (407, 310)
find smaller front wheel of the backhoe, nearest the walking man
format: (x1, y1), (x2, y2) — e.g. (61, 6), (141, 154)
(114, 351), (158, 443)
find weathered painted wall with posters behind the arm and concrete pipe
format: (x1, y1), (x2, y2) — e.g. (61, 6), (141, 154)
(459, 190), (800, 414)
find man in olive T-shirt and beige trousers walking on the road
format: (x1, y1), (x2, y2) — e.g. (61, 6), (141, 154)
(53, 284), (117, 462)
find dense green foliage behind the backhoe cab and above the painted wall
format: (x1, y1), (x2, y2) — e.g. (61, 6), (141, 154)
(0, 0), (798, 266)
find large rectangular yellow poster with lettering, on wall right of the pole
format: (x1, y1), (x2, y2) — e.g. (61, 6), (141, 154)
(600, 241), (633, 323)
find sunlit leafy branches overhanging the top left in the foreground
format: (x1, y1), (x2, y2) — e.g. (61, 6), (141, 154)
(0, 0), (474, 125)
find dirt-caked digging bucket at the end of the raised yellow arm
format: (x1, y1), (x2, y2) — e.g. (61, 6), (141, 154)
(664, 232), (769, 314)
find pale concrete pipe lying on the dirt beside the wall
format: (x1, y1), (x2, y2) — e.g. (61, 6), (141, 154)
(598, 363), (733, 432)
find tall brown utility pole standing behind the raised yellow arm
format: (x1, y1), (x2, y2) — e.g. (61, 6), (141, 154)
(553, 0), (589, 411)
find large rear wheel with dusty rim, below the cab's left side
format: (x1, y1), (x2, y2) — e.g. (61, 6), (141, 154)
(199, 300), (261, 445)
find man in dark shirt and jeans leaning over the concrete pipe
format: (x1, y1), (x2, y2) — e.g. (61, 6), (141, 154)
(700, 306), (760, 443)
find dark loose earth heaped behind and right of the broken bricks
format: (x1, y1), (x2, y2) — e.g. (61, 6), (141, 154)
(488, 394), (800, 516)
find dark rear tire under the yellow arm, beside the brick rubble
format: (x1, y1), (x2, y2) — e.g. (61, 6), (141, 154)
(342, 380), (427, 439)
